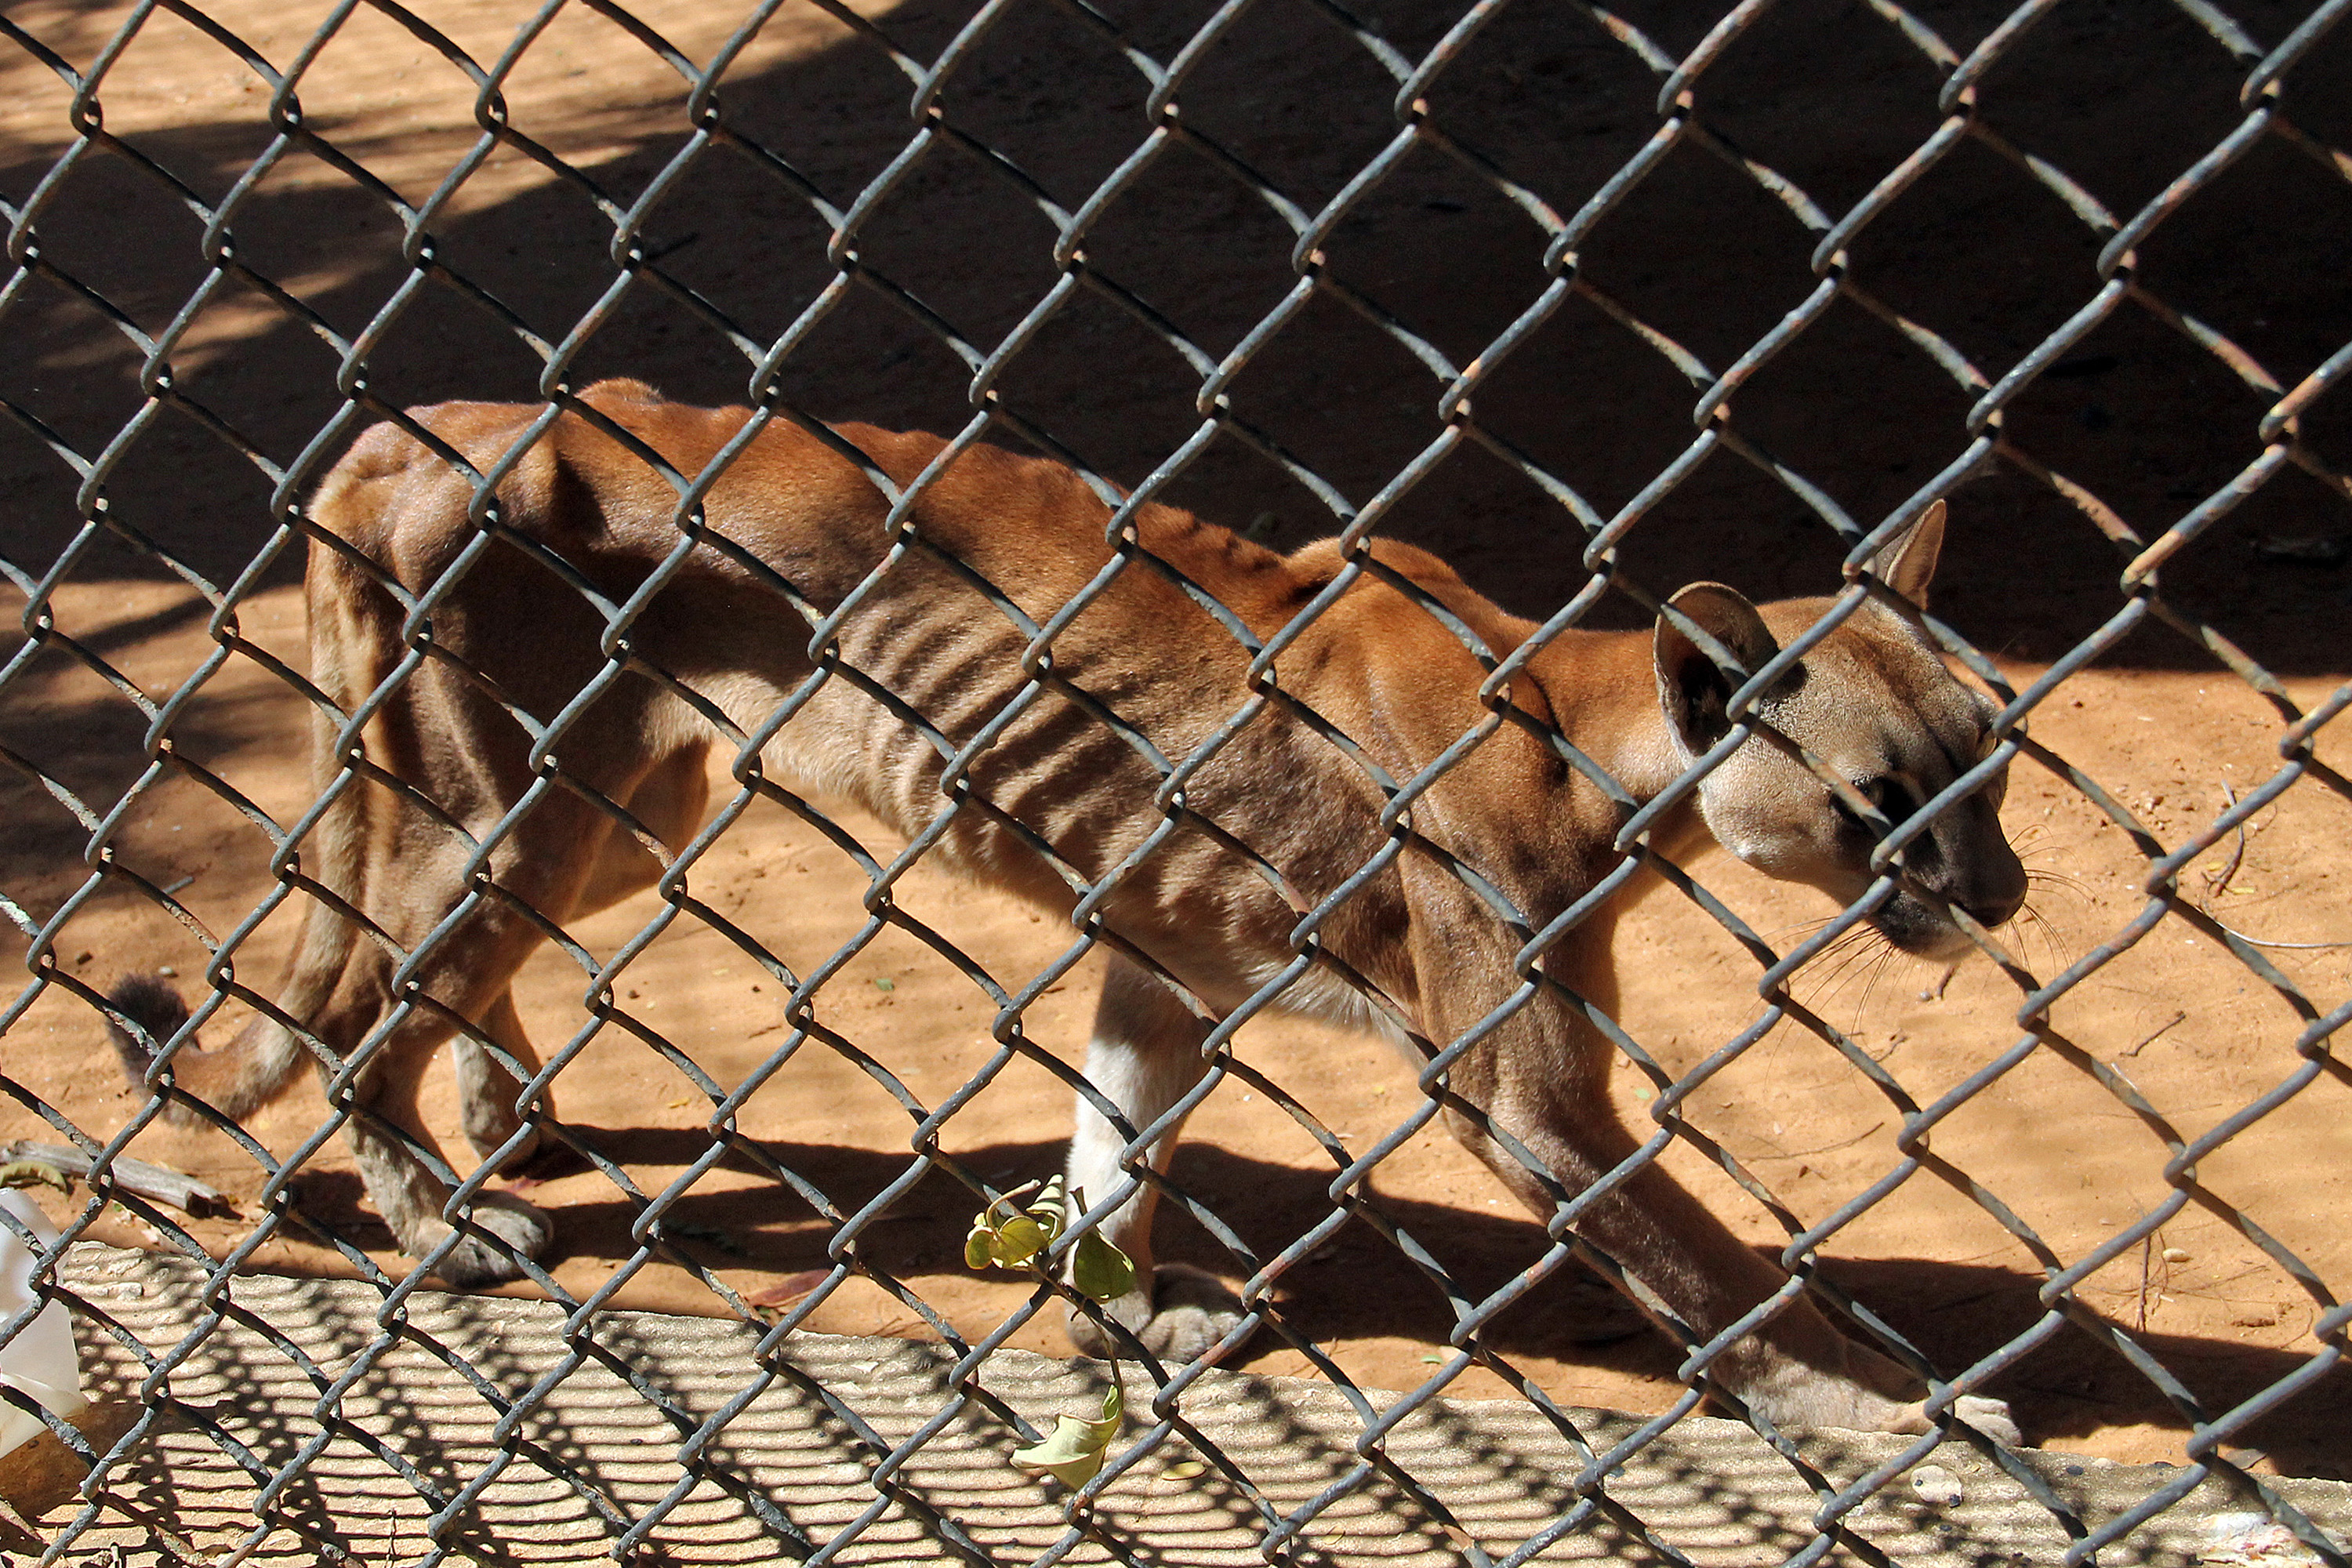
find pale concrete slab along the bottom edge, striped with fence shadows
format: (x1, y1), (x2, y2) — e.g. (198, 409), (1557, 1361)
(9, 1246), (2352, 1568)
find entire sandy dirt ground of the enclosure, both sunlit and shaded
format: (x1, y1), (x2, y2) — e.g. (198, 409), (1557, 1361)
(0, 0), (2352, 1476)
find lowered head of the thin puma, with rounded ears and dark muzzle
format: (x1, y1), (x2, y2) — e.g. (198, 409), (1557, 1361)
(1656, 501), (2025, 956)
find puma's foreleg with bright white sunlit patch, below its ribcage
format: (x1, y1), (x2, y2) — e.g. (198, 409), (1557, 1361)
(1068, 956), (1242, 1363)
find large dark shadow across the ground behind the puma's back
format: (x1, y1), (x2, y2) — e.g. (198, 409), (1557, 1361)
(0, 0), (2352, 673)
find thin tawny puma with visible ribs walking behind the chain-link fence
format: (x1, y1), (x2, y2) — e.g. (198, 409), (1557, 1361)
(115, 381), (2025, 1441)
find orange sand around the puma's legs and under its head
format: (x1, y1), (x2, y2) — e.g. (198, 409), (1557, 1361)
(0, 571), (2352, 1472)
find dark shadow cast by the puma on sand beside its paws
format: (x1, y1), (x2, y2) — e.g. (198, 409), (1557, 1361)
(285, 1123), (2352, 1479)
